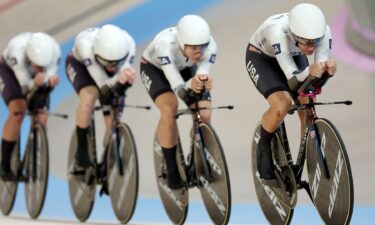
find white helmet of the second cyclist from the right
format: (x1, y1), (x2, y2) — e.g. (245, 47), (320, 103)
(177, 15), (211, 49)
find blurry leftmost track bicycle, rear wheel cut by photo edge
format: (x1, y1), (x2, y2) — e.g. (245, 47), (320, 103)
(0, 85), (68, 219)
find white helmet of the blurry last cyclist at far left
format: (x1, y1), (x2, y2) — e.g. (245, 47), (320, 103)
(26, 32), (56, 67)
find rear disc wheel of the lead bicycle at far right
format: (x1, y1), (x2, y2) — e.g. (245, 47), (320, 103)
(251, 124), (294, 225)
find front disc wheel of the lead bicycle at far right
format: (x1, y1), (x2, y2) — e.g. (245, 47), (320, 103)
(306, 119), (354, 225)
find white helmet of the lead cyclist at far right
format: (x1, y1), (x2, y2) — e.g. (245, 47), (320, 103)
(289, 3), (327, 44)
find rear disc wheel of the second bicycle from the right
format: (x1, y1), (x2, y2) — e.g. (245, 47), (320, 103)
(154, 135), (189, 224)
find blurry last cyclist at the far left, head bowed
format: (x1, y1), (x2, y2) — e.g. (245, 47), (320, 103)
(0, 32), (61, 180)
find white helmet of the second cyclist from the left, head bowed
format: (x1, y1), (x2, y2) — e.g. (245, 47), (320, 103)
(94, 24), (129, 62)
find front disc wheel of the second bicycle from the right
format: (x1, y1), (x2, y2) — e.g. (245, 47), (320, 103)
(194, 123), (231, 224)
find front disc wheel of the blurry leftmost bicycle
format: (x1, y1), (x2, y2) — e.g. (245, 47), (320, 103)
(24, 124), (49, 219)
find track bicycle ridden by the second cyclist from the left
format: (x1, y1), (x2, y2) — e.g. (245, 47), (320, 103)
(68, 91), (150, 224)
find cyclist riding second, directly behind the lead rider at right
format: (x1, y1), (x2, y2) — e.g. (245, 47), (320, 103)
(141, 15), (217, 189)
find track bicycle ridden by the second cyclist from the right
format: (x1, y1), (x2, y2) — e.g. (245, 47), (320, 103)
(154, 92), (233, 224)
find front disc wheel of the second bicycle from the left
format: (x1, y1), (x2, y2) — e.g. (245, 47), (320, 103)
(107, 124), (138, 223)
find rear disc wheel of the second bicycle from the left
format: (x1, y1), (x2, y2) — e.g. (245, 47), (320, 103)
(68, 131), (96, 222)
